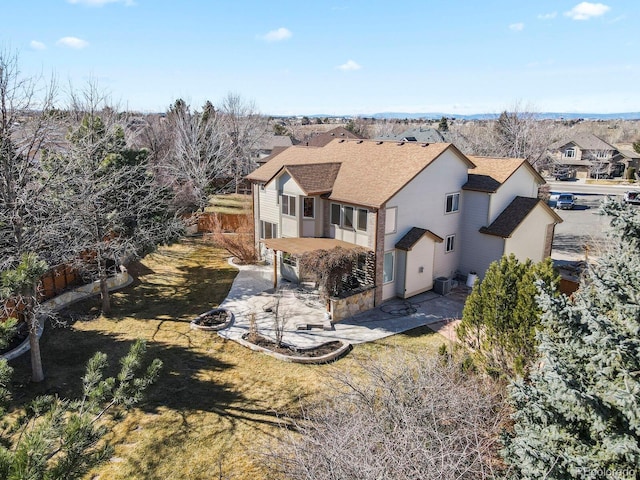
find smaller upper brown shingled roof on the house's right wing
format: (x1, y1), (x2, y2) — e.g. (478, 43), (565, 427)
(462, 156), (545, 192)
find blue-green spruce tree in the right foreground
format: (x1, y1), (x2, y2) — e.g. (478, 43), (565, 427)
(503, 201), (640, 479)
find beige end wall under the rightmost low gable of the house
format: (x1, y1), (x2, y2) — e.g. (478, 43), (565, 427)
(505, 204), (553, 262)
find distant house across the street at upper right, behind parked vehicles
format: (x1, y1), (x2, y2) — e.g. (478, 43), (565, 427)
(549, 133), (627, 178)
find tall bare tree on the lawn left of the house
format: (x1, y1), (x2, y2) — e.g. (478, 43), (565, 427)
(57, 84), (181, 314)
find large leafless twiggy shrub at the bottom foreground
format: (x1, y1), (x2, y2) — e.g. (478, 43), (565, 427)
(267, 352), (506, 480)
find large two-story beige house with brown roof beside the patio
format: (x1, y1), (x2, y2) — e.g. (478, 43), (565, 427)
(247, 140), (562, 312)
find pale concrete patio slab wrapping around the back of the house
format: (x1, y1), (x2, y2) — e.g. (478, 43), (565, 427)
(218, 262), (469, 348)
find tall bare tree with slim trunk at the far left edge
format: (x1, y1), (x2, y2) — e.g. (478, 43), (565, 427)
(0, 50), (68, 382)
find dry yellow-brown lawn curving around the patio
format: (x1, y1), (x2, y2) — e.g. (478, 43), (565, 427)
(7, 240), (442, 480)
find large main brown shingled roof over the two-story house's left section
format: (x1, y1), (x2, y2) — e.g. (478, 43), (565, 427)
(247, 140), (473, 208)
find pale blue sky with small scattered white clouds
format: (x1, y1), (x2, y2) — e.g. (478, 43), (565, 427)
(0, 0), (640, 115)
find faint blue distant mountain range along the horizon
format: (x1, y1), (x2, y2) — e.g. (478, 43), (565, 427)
(308, 112), (640, 120)
